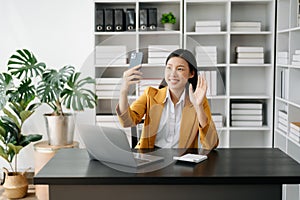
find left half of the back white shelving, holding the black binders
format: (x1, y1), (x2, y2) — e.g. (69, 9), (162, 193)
(94, 0), (183, 145)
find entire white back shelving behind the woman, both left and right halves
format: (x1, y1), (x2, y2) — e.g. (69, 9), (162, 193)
(94, 0), (275, 147)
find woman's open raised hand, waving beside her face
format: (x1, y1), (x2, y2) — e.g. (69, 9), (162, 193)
(189, 74), (207, 108)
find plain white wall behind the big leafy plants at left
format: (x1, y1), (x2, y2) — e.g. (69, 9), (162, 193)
(0, 0), (94, 170)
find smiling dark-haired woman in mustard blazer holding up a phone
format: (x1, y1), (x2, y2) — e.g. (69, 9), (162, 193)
(116, 49), (219, 149)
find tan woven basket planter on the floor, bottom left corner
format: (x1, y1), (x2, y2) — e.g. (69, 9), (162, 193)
(3, 168), (28, 199)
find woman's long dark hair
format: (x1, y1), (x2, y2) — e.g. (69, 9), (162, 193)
(159, 49), (198, 90)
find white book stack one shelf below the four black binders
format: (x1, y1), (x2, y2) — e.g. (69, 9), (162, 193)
(95, 45), (127, 65)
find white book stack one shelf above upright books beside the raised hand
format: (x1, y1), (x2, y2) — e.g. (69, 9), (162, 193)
(195, 46), (217, 66)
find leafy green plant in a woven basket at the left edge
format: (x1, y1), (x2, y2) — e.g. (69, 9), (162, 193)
(0, 49), (45, 198)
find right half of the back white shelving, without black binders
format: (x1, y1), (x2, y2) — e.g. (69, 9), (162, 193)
(183, 0), (275, 147)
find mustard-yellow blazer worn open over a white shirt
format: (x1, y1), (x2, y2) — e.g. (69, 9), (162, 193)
(116, 87), (219, 149)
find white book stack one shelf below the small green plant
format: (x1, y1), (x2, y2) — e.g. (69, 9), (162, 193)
(148, 45), (179, 64)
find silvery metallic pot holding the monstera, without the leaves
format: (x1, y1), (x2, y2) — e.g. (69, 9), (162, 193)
(44, 114), (75, 146)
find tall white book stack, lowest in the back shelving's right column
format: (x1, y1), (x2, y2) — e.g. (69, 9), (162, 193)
(231, 102), (263, 127)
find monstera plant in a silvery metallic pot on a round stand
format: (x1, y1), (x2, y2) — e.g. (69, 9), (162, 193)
(37, 65), (97, 146)
